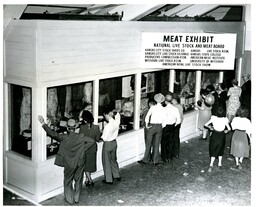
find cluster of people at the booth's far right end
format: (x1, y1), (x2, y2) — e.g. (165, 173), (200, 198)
(196, 74), (251, 172)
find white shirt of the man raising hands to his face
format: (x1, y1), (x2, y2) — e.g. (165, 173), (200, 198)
(101, 113), (121, 142)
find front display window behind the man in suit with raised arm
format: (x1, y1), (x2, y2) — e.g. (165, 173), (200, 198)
(46, 81), (93, 157)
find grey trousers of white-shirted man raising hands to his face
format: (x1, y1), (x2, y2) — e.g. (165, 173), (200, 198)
(102, 140), (120, 182)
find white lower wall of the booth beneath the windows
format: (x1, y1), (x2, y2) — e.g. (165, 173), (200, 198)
(7, 114), (197, 202)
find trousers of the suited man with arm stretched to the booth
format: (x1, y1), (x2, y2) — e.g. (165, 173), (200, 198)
(64, 164), (84, 204)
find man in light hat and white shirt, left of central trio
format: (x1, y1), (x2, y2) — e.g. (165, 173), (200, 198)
(138, 93), (166, 165)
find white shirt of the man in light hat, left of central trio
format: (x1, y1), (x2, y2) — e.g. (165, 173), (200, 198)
(145, 103), (166, 127)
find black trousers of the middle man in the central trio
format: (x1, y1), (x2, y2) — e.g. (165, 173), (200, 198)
(161, 124), (174, 160)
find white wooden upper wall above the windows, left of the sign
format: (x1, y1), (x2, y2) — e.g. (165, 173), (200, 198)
(38, 21), (243, 85)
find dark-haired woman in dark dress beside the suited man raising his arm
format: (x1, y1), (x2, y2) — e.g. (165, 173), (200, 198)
(79, 110), (100, 187)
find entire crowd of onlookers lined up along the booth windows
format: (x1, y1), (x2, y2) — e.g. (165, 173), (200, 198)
(38, 76), (251, 204)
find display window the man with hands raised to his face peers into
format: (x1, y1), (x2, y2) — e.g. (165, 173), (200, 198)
(98, 75), (135, 133)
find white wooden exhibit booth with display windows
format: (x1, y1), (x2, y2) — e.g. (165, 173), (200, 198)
(3, 17), (245, 202)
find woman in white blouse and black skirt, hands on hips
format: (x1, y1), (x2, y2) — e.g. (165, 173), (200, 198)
(205, 106), (231, 172)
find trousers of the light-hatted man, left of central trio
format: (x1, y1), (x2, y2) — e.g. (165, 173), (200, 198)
(142, 124), (162, 163)
